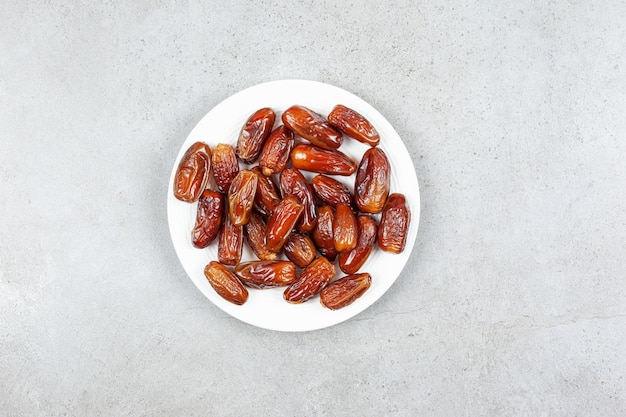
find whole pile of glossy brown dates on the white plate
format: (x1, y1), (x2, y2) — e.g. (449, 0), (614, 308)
(174, 105), (410, 310)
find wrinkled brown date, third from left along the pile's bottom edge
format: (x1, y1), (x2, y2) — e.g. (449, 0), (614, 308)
(283, 256), (335, 303)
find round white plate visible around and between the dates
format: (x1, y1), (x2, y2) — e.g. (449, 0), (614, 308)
(167, 80), (420, 331)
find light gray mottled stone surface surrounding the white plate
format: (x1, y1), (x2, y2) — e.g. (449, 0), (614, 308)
(0, 0), (626, 417)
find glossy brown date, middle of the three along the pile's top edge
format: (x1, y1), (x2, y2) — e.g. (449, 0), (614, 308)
(282, 106), (343, 149)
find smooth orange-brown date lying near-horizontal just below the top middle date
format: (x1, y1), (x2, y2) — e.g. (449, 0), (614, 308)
(291, 143), (356, 176)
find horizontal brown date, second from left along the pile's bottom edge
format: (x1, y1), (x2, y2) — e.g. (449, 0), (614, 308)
(235, 261), (296, 288)
